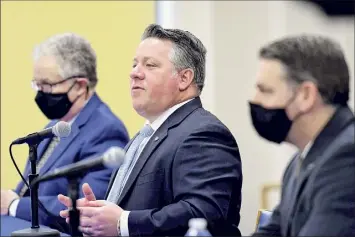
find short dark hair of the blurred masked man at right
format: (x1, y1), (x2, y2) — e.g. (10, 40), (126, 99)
(259, 34), (350, 105)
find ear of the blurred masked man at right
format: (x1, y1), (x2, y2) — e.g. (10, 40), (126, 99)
(298, 81), (319, 113)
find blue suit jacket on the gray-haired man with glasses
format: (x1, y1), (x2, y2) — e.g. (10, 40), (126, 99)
(16, 94), (129, 232)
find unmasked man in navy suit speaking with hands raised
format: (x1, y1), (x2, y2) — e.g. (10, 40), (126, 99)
(59, 25), (242, 236)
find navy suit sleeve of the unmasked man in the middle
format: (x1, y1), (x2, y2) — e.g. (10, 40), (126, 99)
(128, 126), (242, 236)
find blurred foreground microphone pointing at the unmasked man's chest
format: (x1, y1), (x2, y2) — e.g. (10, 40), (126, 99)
(31, 147), (125, 186)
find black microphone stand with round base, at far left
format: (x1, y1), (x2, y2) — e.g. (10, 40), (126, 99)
(11, 141), (60, 237)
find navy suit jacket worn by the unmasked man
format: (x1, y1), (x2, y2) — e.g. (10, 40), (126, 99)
(107, 98), (242, 236)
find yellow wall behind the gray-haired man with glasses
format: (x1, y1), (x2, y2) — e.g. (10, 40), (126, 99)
(1, 1), (155, 188)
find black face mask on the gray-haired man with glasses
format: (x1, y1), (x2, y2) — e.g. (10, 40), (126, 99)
(35, 83), (76, 120)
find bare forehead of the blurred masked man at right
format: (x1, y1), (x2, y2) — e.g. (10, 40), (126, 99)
(256, 59), (286, 87)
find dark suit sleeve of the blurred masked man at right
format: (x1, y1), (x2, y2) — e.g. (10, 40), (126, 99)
(299, 143), (355, 236)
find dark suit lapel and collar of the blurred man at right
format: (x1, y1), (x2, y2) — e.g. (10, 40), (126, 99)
(285, 107), (354, 236)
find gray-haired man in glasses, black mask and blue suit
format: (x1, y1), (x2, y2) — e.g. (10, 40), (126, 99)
(1, 34), (129, 231)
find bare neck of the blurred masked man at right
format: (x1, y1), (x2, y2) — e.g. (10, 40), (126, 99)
(289, 106), (336, 150)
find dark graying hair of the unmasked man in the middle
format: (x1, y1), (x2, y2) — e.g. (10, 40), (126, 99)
(142, 24), (207, 93)
